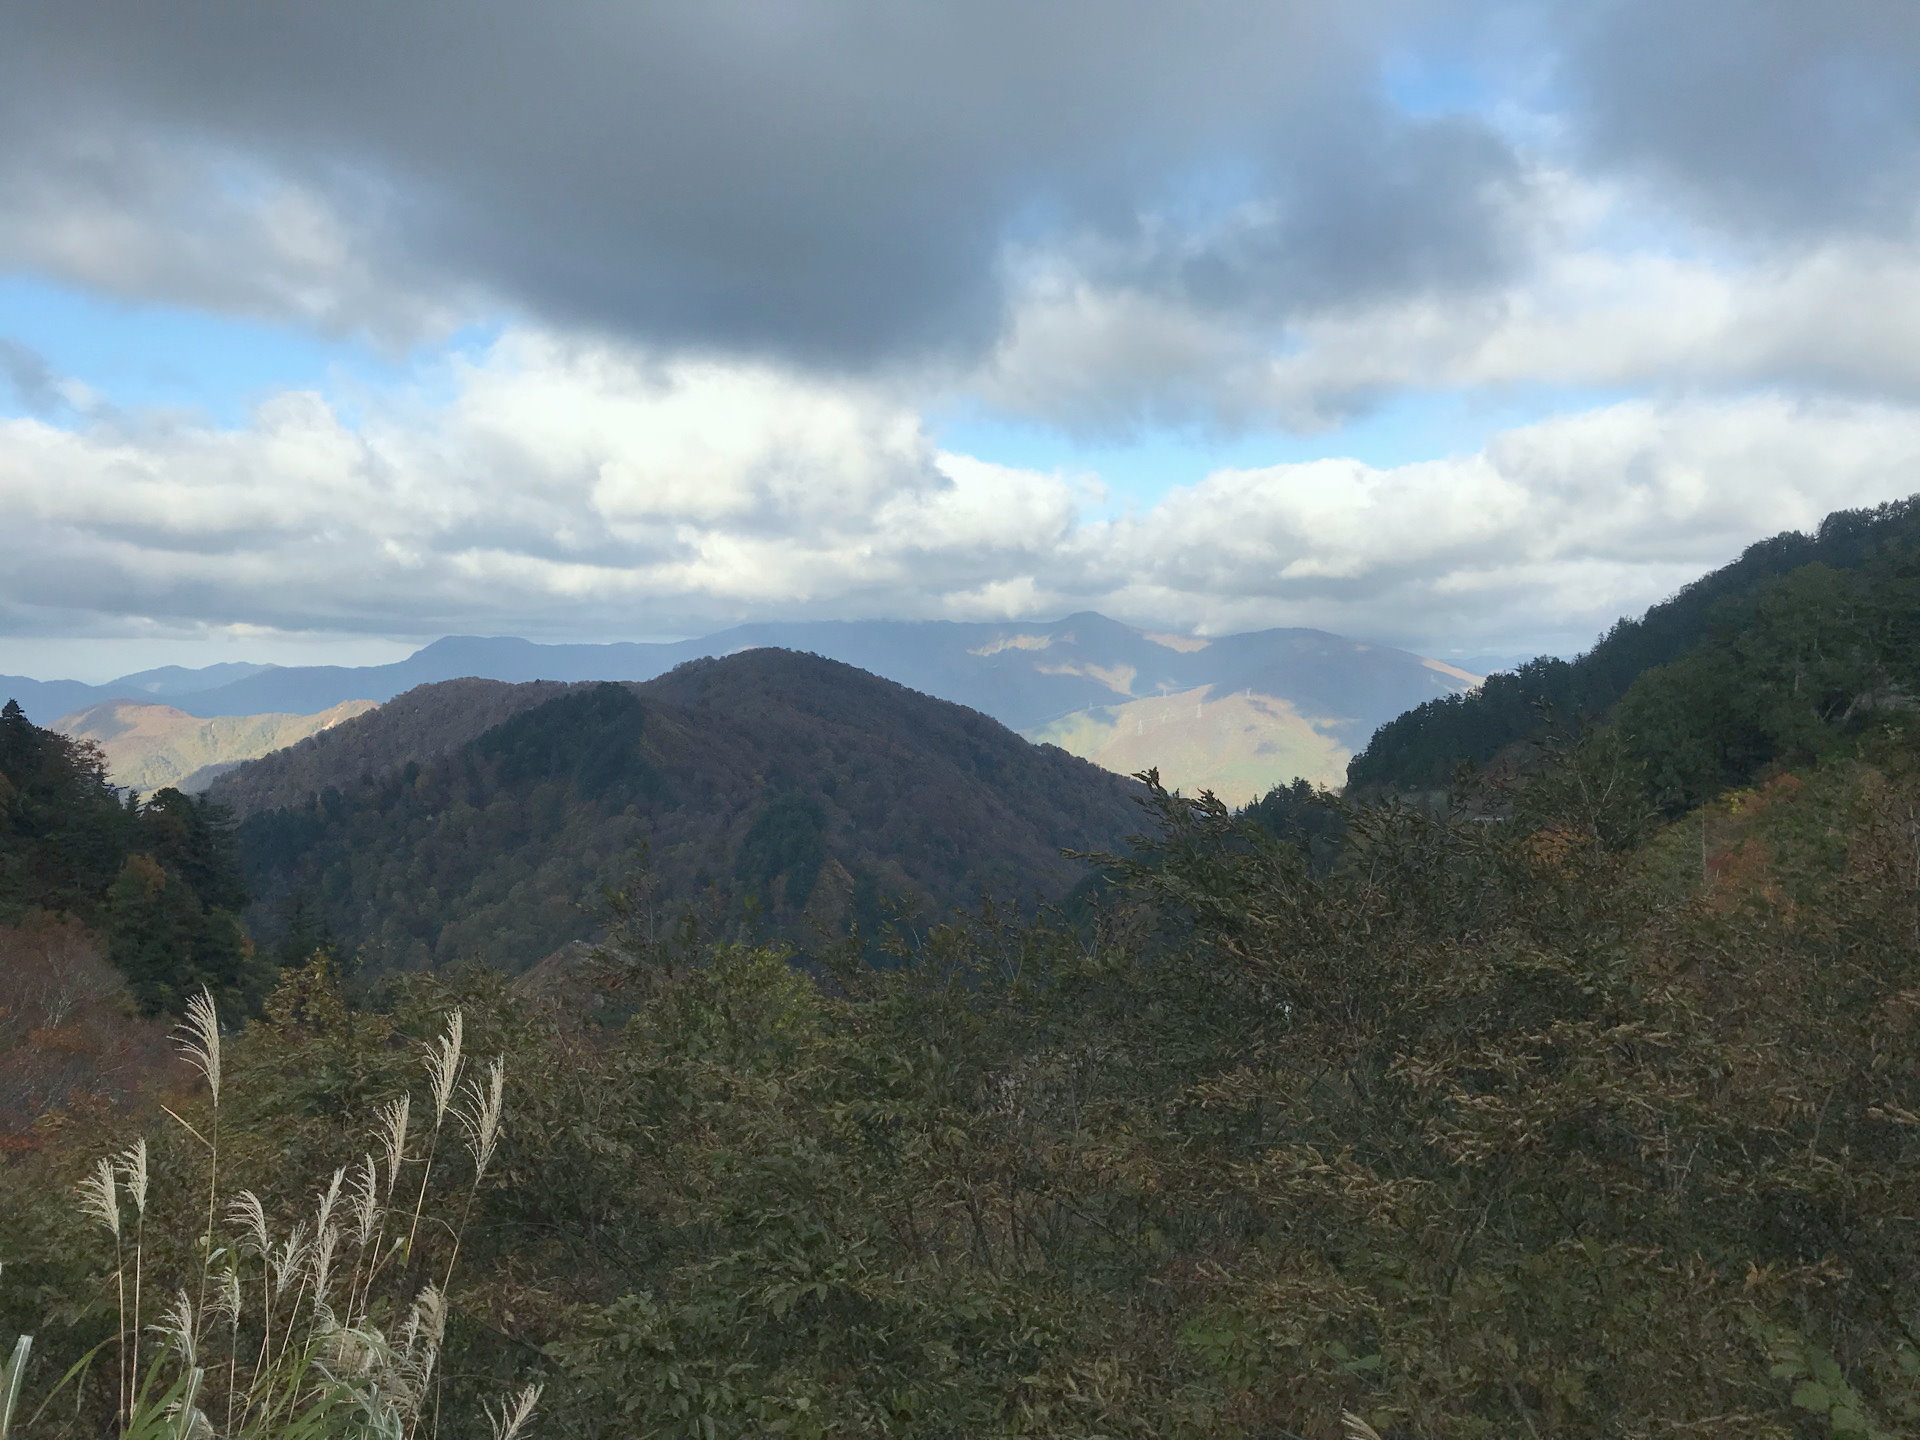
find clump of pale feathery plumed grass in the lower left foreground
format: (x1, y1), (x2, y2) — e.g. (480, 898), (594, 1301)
(35, 995), (540, 1440)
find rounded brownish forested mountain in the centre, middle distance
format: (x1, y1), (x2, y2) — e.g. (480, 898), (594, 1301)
(222, 649), (1139, 970)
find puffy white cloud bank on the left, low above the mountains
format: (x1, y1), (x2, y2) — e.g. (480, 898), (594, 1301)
(0, 332), (1077, 634)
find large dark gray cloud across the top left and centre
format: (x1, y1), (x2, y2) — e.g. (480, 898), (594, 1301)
(0, 0), (1551, 365)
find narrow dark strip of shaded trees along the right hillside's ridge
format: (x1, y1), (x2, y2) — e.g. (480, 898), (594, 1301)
(1348, 497), (1920, 793)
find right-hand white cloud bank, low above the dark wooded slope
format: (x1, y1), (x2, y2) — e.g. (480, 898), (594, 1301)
(1075, 396), (1920, 651)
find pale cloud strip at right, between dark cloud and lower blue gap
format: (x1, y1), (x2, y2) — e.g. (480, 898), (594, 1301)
(972, 171), (1920, 434)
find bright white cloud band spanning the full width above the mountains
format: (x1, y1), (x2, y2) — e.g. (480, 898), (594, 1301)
(0, 330), (1920, 653)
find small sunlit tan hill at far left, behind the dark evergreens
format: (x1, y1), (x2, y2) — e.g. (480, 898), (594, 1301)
(52, 702), (374, 795)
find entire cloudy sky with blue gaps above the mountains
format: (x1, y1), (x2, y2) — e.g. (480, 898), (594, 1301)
(0, 0), (1920, 680)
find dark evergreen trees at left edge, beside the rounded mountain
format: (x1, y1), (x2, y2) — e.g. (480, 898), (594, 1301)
(0, 701), (273, 1012)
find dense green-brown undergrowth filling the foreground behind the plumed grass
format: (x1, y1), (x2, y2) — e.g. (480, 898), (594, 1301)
(11, 716), (1920, 1440)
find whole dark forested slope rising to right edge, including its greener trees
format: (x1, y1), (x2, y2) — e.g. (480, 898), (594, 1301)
(1348, 499), (1920, 799)
